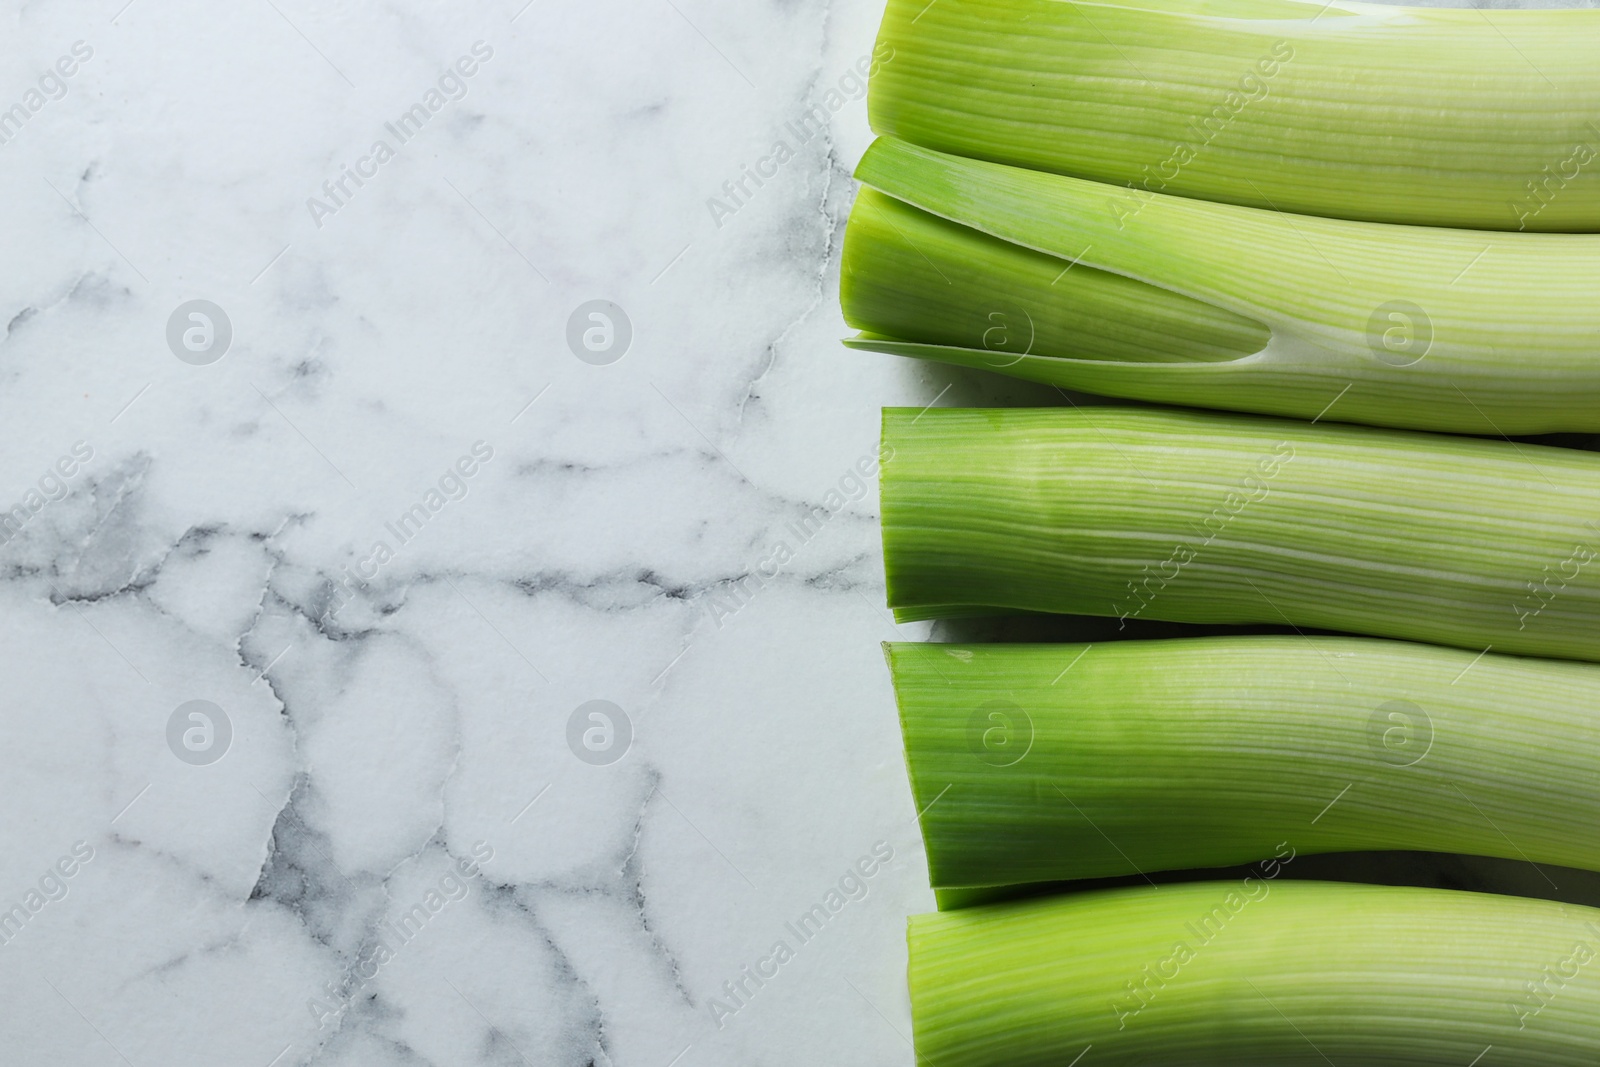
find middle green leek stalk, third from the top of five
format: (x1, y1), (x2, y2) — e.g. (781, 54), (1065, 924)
(880, 408), (1600, 659)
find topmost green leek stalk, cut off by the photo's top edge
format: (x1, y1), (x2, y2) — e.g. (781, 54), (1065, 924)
(869, 0), (1600, 232)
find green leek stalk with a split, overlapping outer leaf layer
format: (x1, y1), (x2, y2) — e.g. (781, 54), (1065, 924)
(840, 140), (1600, 435)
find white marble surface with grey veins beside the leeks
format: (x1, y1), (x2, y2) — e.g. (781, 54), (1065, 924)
(0, 0), (1088, 1067)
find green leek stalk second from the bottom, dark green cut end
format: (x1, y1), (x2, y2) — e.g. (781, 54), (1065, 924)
(886, 635), (1600, 889)
